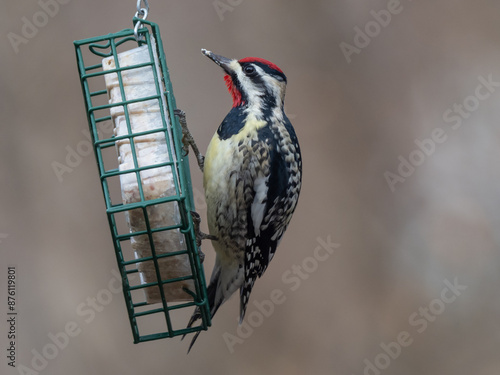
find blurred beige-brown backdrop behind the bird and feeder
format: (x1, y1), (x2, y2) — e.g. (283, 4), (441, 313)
(0, 0), (500, 375)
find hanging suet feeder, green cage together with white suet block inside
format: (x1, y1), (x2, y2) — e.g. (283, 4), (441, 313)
(74, 15), (210, 343)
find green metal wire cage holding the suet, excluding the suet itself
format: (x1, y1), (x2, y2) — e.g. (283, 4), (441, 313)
(74, 18), (211, 343)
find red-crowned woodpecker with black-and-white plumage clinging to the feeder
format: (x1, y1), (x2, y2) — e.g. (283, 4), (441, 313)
(177, 49), (302, 349)
